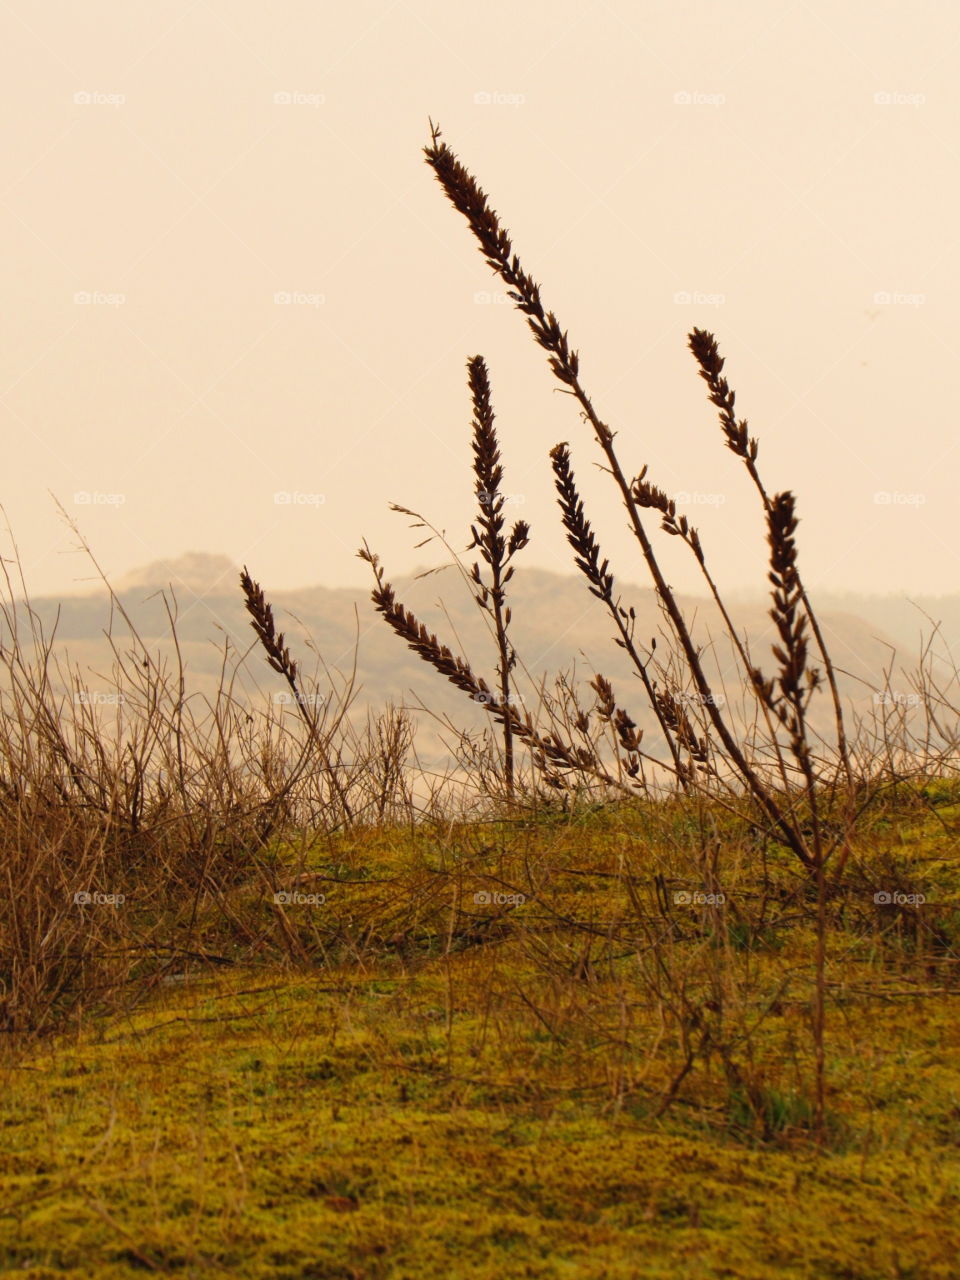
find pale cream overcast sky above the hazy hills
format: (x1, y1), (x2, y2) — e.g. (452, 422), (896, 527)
(0, 0), (960, 594)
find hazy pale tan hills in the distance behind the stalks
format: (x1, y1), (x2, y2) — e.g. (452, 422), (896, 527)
(9, 553), (960, 759)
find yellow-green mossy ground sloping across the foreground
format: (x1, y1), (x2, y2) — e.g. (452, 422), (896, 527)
(0, 806), (960, 1280)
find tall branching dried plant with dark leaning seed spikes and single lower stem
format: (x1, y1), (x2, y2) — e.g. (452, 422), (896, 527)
(424, 124), (852, 1133)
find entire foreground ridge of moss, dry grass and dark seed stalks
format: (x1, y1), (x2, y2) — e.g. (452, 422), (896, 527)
(0, 129), (960, 1280)
